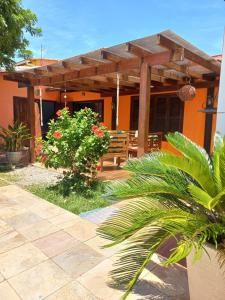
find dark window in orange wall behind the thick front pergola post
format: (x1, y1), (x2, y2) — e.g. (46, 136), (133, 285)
(130, 95), (184, 133)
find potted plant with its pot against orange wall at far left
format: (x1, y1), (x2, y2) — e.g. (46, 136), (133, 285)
(0, 122), (31, 164)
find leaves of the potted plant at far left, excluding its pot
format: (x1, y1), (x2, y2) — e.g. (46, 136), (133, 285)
(0, 122), (31, 152)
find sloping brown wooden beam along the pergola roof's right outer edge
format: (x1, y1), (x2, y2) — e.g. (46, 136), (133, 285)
(158, 34), (220, 74)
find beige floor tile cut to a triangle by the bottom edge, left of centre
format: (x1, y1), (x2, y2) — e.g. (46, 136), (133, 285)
(46, 281), (97, 300)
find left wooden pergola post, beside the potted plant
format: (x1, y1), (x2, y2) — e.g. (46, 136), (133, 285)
(27, 86), (36, 163)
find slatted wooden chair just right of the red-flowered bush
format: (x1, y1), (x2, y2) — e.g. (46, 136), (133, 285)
(100, 130), (129, 172)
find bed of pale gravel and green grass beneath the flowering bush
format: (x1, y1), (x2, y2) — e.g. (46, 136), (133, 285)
(0, 165), (110, 214)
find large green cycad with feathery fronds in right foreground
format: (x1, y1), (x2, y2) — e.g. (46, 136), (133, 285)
(98, 132), (225, 299)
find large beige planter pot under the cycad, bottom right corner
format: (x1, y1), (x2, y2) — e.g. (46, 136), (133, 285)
(187, 245), (225, 300)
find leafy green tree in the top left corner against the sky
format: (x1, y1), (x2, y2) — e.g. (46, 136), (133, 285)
(0, 0), (41, 70)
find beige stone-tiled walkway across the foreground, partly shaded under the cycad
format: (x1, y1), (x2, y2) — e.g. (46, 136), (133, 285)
(0, 185), (189, 300)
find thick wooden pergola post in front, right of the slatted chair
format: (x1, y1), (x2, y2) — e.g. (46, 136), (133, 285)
(137, 61), (151, 157)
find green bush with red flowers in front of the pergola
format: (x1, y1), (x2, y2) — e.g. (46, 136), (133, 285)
(36, 108), (110, 192)
